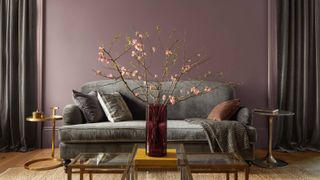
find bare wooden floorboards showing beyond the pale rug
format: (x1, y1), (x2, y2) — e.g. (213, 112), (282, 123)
(0, 149), (320, 173)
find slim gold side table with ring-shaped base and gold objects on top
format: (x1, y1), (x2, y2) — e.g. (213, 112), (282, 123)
(24, 107), (62, 171)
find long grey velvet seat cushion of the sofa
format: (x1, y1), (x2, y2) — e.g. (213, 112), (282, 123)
(59, 120), (207, 143)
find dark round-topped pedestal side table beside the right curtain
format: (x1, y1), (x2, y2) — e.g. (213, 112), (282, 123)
(253, 109), (294, 168)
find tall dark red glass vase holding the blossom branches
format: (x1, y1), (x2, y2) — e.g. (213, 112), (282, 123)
(146, 104), (167, 157)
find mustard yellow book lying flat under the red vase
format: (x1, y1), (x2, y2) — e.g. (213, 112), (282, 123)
(134, 148), (177, 168)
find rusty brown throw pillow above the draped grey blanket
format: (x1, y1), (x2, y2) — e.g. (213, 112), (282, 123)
(207, 99), (240, 121)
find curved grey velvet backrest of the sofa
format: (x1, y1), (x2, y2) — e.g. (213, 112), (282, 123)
(81, 80), (234, 120)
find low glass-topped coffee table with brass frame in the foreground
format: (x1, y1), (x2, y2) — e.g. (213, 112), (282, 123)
(67, 143), (249, 180)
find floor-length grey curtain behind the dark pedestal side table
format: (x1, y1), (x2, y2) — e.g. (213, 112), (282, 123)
(274, 0), (320, 151)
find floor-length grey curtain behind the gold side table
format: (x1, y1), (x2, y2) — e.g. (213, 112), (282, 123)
(0, 0), (37, 151)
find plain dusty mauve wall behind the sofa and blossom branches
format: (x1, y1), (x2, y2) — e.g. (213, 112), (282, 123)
(44, 0), (267, 146)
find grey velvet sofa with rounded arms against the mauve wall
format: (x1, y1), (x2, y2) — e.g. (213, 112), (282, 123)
(59, 80), (256, 167)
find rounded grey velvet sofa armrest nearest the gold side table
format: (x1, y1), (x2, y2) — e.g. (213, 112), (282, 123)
(63, 104), (85, 125)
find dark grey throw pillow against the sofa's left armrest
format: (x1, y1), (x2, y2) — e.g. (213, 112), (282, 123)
(72, 90), (107, 123)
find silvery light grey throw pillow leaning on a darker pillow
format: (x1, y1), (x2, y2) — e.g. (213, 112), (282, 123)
(98, 92), (132, 122)
